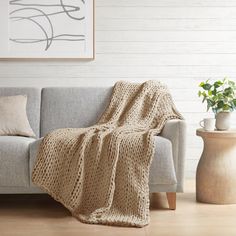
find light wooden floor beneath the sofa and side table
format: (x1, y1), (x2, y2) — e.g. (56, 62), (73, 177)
(0, 181), (236, 236)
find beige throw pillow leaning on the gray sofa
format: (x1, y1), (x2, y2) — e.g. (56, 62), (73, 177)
(0, 95), (35, 137)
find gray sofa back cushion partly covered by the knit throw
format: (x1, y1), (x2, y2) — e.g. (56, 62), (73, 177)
(41, 87), (112, 137)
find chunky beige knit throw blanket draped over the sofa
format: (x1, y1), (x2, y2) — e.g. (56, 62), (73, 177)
(32, 81), (181, 227)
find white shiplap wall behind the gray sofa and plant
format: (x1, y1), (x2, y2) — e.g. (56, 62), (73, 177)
(0, 0), (236, 177)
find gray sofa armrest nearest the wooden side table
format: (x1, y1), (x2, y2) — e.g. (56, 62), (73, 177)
(160, 120), (186, 192)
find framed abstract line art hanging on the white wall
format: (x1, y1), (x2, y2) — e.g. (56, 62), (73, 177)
(0, 0), (94, 59)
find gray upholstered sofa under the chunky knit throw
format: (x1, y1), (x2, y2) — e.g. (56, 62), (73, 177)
(0, 87), (186, 206)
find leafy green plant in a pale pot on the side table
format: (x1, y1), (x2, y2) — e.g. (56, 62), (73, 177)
(198, 78), (236, 130)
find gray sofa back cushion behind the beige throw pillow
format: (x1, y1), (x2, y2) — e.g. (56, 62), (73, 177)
(0, 87), (41, 137)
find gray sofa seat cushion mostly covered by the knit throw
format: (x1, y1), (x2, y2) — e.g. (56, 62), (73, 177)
(30, 136), (177, 186)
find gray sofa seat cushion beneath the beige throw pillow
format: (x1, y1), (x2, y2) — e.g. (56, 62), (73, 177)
(0, 136), (35, 187)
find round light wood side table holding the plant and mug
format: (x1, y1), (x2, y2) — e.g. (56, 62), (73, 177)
(196, 129), (236, 204)
